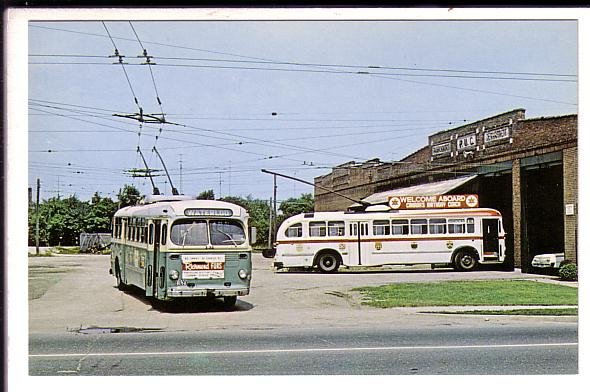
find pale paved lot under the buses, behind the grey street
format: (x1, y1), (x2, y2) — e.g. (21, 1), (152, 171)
(29, 251), (572, 333)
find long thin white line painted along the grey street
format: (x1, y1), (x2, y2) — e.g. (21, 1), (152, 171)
(29, 342), (578, 358)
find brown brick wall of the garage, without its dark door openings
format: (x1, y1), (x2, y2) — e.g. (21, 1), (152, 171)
(315, 109), (578, 266)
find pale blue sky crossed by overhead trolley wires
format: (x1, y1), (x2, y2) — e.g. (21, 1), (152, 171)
(22, 13), (578, 201)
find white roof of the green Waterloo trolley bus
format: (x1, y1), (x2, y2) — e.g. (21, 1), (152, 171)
(115, 199), (248, 218)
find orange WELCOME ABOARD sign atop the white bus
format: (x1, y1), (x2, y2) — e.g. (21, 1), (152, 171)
(387, 195), (479, 210)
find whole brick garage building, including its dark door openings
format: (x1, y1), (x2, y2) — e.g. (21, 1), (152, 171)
(315, 109), (578, 272)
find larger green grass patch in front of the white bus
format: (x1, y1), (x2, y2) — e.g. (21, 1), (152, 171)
(353, 280), (578, 308)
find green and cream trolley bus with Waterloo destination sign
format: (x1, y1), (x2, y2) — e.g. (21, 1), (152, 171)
(110, 195), (256, 307)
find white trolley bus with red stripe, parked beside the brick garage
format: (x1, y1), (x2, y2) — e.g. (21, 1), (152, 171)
(274, 208), (506, 272)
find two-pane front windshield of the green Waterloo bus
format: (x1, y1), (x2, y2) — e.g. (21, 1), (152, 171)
(170, 219), (246, 246)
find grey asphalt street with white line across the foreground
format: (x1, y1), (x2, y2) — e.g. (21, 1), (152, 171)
(29, 325), (578, 376)
